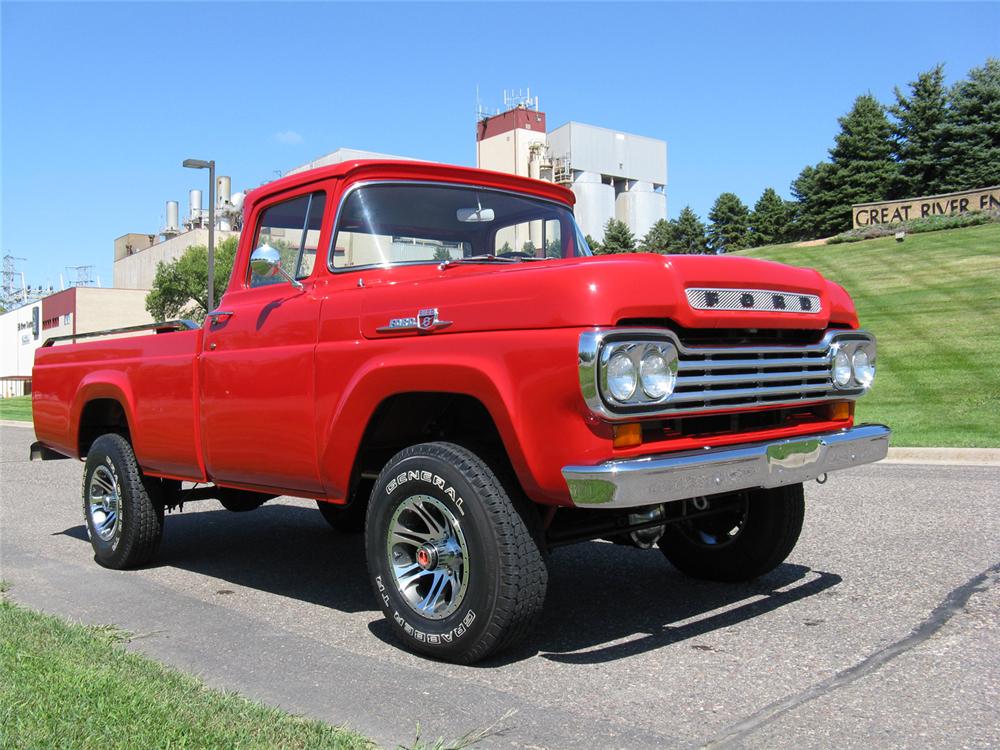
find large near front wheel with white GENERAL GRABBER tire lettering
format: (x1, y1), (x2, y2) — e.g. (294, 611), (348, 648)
(365, 442), (548, 664)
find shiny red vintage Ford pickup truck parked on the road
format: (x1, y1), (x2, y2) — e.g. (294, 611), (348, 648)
(32, 161), (889, 663)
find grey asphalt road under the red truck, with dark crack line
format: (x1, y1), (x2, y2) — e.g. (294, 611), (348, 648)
(0, 427), (1000, 748)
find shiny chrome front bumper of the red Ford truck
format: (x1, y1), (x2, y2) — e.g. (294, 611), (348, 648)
(562, 424), (891, 508)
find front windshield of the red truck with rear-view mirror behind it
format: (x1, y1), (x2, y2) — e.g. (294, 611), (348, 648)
(330, 183), (591, 269)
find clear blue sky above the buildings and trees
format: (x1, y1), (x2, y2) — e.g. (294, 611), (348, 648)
(0, 2), (1000, 285)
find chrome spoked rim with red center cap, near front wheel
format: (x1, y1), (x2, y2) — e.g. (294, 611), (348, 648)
(386, 495), (469, 620)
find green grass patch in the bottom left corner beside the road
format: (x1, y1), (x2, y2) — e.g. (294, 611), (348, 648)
(0, 601), (373, 750)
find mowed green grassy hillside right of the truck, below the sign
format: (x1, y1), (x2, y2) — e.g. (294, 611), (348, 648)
(740, 224), (1000, 448)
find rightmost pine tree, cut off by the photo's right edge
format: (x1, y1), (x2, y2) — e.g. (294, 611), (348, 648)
(943, 57), (1000, 191)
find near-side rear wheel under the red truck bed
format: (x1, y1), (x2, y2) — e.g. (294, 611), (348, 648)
(83, 434), (163, 570)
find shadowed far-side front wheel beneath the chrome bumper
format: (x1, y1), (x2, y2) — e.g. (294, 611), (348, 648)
(659, 484), (805, 581)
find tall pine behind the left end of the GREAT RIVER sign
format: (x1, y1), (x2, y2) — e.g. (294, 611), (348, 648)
(830, 94), (898, 225)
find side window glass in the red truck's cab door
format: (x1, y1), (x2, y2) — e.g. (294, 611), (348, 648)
(250, 193), (326, 287)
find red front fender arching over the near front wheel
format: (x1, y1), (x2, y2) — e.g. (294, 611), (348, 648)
(317, 329), (595, 503)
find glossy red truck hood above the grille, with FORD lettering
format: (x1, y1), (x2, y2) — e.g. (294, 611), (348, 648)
(362, 254), (857, 338)
